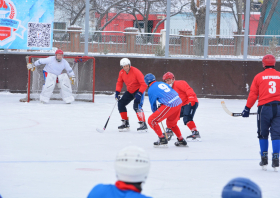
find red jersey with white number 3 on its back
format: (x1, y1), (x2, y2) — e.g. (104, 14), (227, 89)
(246, 68), (280, 108)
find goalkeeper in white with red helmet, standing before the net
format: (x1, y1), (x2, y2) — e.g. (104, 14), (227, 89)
(27, 49), (75, 104)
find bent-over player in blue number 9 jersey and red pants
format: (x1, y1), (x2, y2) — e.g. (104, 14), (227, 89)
(144, 73), (187, 147)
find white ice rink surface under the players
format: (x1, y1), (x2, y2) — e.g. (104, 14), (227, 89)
(0, 93), (280, 198)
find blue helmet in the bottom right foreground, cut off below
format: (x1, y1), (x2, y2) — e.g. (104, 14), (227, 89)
(222, 177), (262, 198)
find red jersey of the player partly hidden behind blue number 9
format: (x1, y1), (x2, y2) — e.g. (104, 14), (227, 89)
(172, 80), (198, 106)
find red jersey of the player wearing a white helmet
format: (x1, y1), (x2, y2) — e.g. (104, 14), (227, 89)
(116, 66), (148, 94)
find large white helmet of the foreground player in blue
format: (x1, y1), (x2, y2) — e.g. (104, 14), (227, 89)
(115, 146), (150, 183)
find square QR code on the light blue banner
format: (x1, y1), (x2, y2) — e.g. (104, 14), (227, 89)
(27, 23), (51, 47)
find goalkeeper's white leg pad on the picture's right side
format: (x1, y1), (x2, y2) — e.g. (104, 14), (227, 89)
(58, 73), (75, 103)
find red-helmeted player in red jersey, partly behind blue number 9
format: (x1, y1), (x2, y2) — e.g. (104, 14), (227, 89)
(162, 72), (201, 141)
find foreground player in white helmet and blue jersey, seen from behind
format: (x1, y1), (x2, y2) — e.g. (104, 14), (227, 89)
(87, 146), (150, 198)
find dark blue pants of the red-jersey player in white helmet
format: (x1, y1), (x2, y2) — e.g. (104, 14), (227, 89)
(118, 90), (145, 113)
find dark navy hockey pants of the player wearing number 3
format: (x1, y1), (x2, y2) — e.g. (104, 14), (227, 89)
(257, 101), (280, 140)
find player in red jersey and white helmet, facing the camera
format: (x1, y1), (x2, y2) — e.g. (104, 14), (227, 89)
(115, 58), (148, 132)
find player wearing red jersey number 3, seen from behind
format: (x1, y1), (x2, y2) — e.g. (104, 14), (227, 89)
(242, 54), (280, 170)
